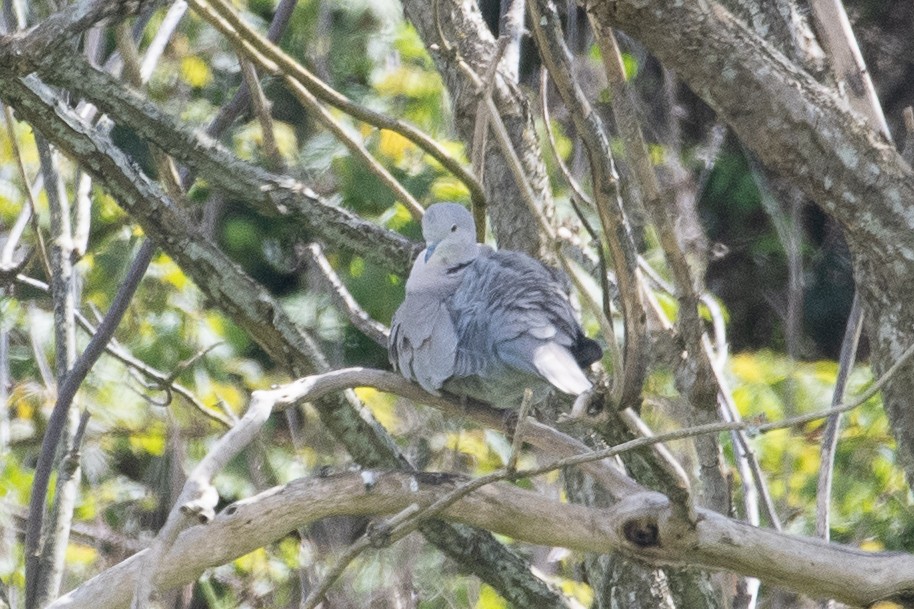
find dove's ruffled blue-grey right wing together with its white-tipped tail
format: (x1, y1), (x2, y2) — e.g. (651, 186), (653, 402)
(449, 252), (600, 395)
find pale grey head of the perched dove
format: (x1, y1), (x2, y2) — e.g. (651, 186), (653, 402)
(422, 203), (479, 267)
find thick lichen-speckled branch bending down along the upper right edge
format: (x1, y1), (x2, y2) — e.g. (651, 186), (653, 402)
(587, 0), (914, 490)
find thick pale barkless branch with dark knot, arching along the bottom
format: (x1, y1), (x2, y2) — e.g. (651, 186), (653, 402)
(50, 472), (914, 609)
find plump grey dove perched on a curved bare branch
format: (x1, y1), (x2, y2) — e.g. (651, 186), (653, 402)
(388, 203), (603, 407)
